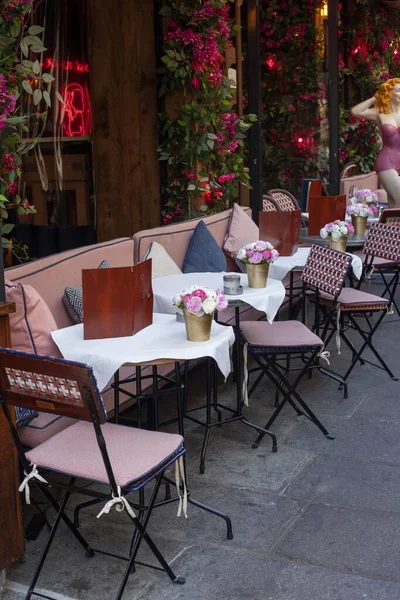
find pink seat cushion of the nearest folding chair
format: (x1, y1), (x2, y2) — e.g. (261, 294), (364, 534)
(26, 421), (183, 489)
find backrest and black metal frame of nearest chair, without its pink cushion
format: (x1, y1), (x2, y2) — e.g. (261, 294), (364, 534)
(0, 349), (189, 600)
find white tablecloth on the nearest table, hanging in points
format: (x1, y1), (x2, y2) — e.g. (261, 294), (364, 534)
(51, 314), (235, 390)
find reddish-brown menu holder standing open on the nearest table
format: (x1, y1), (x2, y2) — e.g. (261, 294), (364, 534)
(82, 259), (153, 340)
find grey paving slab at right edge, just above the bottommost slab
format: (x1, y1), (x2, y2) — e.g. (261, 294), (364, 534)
(274, 504), (400, 584)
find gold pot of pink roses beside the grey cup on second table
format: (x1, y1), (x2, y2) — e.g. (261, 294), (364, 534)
(237, 240), (279, 288)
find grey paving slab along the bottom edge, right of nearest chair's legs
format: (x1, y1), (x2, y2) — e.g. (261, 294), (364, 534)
(136, 546), (400, 600)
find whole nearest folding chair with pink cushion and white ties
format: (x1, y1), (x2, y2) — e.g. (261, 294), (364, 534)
(0, 349), (187, 600)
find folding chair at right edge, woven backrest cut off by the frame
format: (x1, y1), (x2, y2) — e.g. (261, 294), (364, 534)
(310, 223), (400, 398)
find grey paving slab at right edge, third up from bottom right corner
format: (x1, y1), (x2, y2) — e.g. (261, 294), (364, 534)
(285, 455), (400, 513)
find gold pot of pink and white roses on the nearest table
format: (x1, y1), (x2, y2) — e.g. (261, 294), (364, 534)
(172, 285), (228, 342)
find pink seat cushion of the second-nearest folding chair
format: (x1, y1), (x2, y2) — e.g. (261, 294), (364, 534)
(240, 321), (324, 348)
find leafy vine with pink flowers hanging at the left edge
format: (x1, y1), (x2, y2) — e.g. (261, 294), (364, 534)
(0, 0), (62, 247)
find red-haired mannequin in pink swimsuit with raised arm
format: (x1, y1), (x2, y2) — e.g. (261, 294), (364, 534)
(351, 79), (400, 208)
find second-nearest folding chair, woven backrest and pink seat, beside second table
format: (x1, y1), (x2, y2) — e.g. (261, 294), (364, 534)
(241, 245), (351, 447)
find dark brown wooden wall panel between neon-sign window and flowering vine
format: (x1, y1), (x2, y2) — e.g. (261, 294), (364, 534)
(88, 0), (160, 241)
